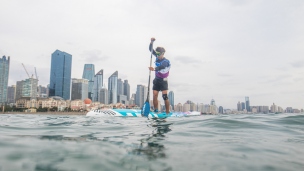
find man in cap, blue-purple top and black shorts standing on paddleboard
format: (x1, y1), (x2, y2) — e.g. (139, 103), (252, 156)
(149, 37), (171, 114)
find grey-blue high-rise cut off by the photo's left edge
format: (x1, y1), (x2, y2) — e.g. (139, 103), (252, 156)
(0, 56), (10, 105)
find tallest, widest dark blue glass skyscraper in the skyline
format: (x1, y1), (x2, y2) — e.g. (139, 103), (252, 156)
(49, 50), (72, 100)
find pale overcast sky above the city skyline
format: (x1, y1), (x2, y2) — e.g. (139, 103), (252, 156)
(0, 0), (304, 109)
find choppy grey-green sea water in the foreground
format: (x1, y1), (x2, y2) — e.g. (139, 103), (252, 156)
(0, 114), (304, 171)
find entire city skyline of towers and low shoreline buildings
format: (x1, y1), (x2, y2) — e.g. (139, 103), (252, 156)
(0, 50), (303, 114)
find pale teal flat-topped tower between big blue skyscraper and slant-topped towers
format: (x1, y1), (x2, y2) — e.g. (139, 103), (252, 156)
(82, 64), (95, 100)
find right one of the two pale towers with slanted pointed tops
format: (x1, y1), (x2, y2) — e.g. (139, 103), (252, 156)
(108, 71), (118, 104)
